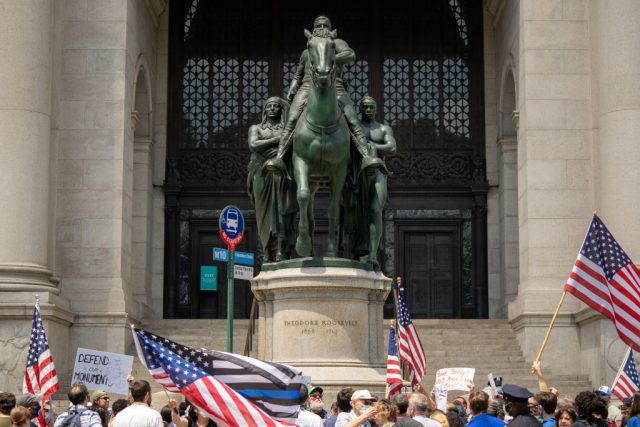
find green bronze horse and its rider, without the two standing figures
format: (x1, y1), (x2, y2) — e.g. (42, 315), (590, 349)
(262, 16), (387, 257)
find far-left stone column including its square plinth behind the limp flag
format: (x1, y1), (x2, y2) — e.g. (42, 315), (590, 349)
(0, 0), (73, 391)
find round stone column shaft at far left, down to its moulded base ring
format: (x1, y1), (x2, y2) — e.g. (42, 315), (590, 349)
(0, 0), (56, 291)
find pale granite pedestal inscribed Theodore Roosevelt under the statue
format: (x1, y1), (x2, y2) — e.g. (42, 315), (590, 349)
(251, 258), (391, 391)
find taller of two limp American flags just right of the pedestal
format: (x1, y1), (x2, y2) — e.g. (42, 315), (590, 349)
(398, 283), (427, 387)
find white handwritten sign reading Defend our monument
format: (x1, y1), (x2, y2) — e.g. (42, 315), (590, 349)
(71, 348), (133, 395)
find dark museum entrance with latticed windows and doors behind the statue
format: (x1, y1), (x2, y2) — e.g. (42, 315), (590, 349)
(164, 0), (488, 318)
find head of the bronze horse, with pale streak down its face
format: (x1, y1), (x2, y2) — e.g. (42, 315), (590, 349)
(304, 30), (336, 87)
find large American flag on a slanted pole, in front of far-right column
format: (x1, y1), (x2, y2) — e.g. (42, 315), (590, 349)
(564, 215), (640, 351)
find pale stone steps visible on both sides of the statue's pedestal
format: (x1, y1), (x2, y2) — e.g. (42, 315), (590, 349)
(134, 319), (592, 402)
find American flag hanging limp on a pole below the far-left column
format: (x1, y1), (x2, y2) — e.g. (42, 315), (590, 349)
(22, 304), (60, 425)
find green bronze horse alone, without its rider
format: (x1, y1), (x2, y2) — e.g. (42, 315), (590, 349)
(292, 30), (351, 256)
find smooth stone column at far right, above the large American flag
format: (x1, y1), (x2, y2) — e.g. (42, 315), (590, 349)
(593, 0), (640, 254)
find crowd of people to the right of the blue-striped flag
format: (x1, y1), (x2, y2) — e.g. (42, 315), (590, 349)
(298, 384), (640, 427)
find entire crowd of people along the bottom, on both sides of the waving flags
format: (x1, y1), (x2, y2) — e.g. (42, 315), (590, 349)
(0, 364), (640, 427)
